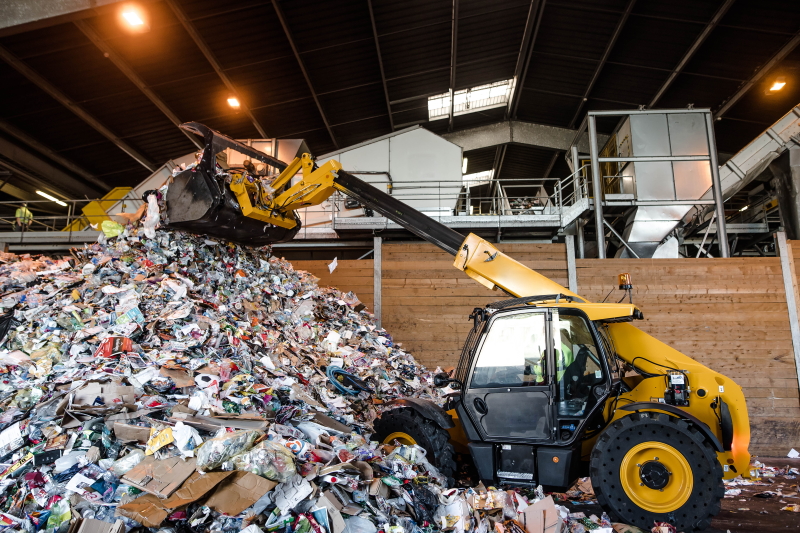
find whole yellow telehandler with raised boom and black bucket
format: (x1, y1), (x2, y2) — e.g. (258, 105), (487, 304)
(166, 123), (750, 531)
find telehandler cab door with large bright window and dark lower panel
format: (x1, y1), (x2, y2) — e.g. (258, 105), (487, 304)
(464, 309), (553, 442)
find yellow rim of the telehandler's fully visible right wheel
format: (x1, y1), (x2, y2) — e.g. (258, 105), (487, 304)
(619, 441), (694, 513)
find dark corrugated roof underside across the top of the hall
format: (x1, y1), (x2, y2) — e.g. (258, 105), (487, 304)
(0, 0), (800, 195)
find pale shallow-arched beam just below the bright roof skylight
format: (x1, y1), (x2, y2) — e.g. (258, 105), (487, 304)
(442, 120), (608, 153)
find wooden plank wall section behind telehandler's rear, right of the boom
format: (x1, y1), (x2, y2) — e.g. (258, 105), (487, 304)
(577, 257), (800, 456)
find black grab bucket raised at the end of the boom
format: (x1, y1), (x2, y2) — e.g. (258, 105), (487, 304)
(166, 123), (301, 246)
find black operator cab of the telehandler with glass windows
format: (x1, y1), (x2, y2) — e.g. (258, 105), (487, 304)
(456, 295), (616, 487)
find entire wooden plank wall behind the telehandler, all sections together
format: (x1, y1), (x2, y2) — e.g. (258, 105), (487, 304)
(294, 241), (800, 456)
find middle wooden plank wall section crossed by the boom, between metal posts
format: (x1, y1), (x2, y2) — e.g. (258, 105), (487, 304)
(382, 243), (567, 368)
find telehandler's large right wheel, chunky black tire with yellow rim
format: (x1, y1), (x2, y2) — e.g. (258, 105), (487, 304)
(590, 412), (725, 533)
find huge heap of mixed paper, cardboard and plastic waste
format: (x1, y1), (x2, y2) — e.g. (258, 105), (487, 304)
(0, 191), (676, 533)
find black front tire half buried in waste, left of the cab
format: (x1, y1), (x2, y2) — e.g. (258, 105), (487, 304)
(372, 407), (456, 485)
